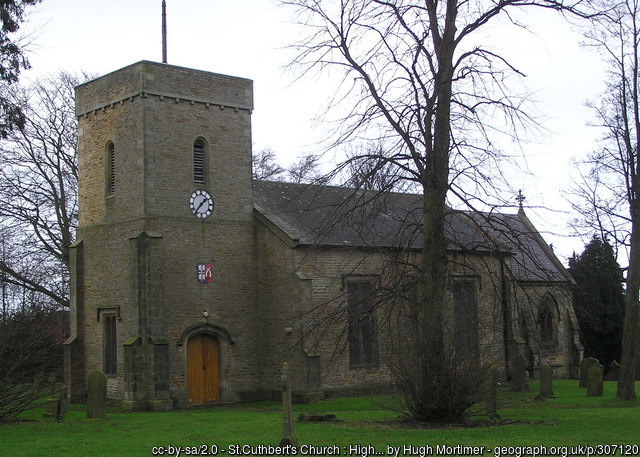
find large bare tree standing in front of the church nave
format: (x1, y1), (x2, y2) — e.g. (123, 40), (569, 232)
(282, 0), (587, 420)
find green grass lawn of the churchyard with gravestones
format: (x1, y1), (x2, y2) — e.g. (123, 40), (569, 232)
(0, 380), (640, 457)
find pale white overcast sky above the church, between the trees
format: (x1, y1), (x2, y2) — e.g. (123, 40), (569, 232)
(17, 0), (605, 263)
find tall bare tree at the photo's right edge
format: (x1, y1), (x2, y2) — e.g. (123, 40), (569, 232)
(574, 0), (640, 400)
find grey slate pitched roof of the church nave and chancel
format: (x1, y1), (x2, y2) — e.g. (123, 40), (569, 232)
(253, 180), (572, 282)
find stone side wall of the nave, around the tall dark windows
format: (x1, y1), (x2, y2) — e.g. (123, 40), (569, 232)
(256, 219), (505, 393)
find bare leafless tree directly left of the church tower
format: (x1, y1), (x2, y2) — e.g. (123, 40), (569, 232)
(0, 73), (79, 306)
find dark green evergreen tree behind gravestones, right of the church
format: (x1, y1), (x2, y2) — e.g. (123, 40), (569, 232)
(569, 236), (624, 368)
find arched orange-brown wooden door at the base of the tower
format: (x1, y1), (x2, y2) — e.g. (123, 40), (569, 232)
(187, 335), (220, 405)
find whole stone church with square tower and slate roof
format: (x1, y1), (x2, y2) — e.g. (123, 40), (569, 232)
(65, 61), (582, 410)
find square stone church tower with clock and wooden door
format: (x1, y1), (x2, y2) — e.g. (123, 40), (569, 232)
(65, 61), (260, 410)
